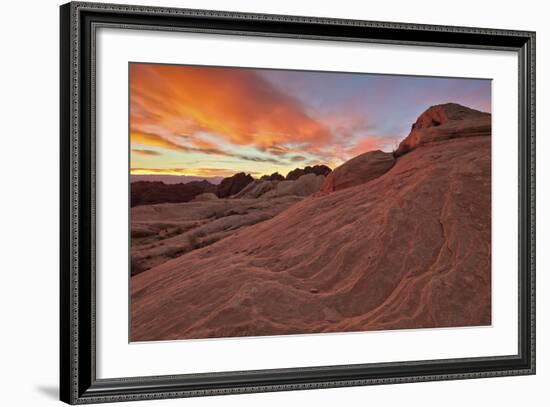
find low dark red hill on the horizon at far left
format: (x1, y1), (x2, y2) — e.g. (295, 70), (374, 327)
(130, 181), (216, 207)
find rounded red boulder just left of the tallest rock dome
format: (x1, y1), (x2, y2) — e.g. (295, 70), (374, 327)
(321, 150), (395, 192)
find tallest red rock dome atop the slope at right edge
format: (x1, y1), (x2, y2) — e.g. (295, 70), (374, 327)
(394, 103), (491, 157)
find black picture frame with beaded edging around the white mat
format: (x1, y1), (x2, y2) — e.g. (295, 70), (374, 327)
(60, 2), (535, 404)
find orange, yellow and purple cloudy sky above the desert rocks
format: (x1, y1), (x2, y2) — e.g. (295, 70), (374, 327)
(130, 63), (491, 177)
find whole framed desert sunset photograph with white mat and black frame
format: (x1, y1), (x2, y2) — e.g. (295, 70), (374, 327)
(60, 2), (535, 404)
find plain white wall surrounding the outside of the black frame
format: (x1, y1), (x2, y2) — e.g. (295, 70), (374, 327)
(0, 0), (550, 406)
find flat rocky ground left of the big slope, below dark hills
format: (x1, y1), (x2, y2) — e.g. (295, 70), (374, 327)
(130, 194), (302, 275)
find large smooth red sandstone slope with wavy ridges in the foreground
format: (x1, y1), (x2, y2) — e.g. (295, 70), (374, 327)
(130, 135), (491, 341)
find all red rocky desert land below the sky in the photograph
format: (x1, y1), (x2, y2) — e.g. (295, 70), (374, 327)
(130, 103), (491, 341)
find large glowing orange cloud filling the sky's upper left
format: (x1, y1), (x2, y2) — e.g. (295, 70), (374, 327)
(130, 64), (331, 148)
